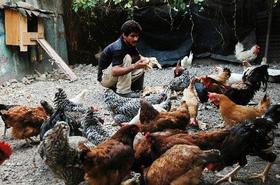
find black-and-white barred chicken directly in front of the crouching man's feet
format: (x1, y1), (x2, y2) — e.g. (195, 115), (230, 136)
(104, 89), (167, 123)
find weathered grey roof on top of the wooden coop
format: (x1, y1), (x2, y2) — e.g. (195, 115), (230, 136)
(1, 1), (54, 18)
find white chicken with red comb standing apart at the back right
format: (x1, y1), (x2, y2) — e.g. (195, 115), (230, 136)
(235, 42), (260, 62)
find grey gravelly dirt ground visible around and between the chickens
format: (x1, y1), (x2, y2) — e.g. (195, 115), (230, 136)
(0, 60), (280, 185)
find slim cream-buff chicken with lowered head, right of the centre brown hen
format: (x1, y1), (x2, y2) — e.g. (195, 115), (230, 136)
(182, 78), (199, 125)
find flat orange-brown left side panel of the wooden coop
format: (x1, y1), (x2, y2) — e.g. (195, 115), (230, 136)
(5, 9), (20, 46)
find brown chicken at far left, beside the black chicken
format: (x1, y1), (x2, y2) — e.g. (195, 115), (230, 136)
(2, 104), (48, 144)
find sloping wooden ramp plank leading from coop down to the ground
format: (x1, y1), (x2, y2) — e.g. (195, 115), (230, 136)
(36, 39), (78, 81)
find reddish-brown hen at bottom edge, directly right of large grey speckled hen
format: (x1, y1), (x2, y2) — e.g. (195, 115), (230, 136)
(79, 125), (139, 185)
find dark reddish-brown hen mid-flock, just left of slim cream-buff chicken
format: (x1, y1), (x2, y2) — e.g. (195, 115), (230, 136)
(140, 100), (190, 132)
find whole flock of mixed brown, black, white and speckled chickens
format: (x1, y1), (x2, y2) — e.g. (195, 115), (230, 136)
(0, 42), (280, 185)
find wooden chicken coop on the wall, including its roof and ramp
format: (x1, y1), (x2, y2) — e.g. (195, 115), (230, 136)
(4, 2), (77, 81)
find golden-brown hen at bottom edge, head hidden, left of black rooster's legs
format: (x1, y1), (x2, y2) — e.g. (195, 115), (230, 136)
(144, 145), (221, 185)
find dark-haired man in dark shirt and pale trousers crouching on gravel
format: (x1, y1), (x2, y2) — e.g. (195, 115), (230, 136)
(97, 20), (149, 97)
